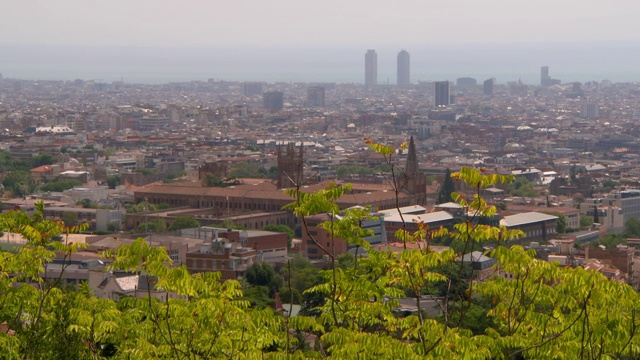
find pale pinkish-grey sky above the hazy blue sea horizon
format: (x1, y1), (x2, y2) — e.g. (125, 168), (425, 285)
(0, 0), (640, 49)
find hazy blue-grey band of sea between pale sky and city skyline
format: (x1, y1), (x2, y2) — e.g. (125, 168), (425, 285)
(0, 41), (640, 85)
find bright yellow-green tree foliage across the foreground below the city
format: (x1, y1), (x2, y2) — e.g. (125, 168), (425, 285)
(0, 140), (640, 359)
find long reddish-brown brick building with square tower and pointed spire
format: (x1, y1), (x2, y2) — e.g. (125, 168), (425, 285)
(128, 138), (427, 229)
